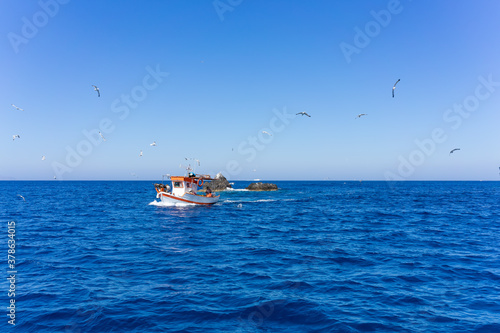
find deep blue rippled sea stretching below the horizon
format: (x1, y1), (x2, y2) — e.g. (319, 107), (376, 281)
(0, 181), (500, 332)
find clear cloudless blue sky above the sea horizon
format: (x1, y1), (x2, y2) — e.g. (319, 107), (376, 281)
(0, 0), (500, 180)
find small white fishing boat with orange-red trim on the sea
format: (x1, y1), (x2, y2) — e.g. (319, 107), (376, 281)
(154, 173), (220, 205)
